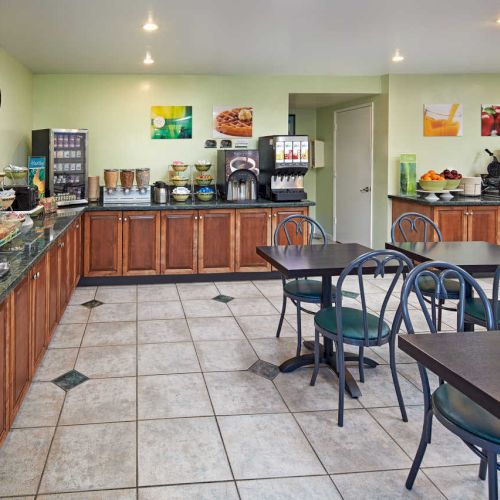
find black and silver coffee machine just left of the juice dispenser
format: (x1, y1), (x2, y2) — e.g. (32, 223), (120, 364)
(217, 149), (259, 201)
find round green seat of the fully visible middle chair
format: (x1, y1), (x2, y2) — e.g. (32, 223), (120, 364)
(314, 307), (391, 341)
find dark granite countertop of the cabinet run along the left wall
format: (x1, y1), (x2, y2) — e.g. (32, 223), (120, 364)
(0, 207), (85, 301)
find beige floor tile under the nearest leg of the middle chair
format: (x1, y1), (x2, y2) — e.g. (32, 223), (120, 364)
(295, 410), (411, 474)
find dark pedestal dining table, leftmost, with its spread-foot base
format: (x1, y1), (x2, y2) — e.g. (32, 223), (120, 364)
(256, 243), (378, 398)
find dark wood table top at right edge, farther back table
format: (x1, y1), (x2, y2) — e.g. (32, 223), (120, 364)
(385, 241), (500, 273)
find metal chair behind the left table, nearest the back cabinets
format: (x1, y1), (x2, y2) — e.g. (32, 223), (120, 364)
(273, 215), (335, 356)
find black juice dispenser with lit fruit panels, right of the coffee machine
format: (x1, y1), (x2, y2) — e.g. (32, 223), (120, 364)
(259, 135), (309, 201)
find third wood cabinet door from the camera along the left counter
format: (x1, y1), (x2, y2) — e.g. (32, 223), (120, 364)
(30, 255), (49, 373)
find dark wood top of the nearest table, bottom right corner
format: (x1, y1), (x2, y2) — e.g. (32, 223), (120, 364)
(398, 332), (500, 418)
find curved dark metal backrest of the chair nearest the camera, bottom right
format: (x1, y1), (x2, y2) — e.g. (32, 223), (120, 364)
(394, 261), (495, 410)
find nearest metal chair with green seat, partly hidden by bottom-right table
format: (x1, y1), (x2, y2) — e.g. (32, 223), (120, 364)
(397, 262), (500, 500)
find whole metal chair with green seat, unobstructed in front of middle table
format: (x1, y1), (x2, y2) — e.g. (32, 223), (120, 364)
(311, 250), (413, 427)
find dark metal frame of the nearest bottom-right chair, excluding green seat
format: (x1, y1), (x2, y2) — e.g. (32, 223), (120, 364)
(395, 261), (500, 500)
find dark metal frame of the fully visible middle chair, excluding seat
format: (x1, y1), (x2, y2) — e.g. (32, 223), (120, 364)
(311, 250), (413, 427)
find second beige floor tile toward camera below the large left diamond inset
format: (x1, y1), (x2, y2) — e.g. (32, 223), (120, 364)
(40, 422), (136, 493)
